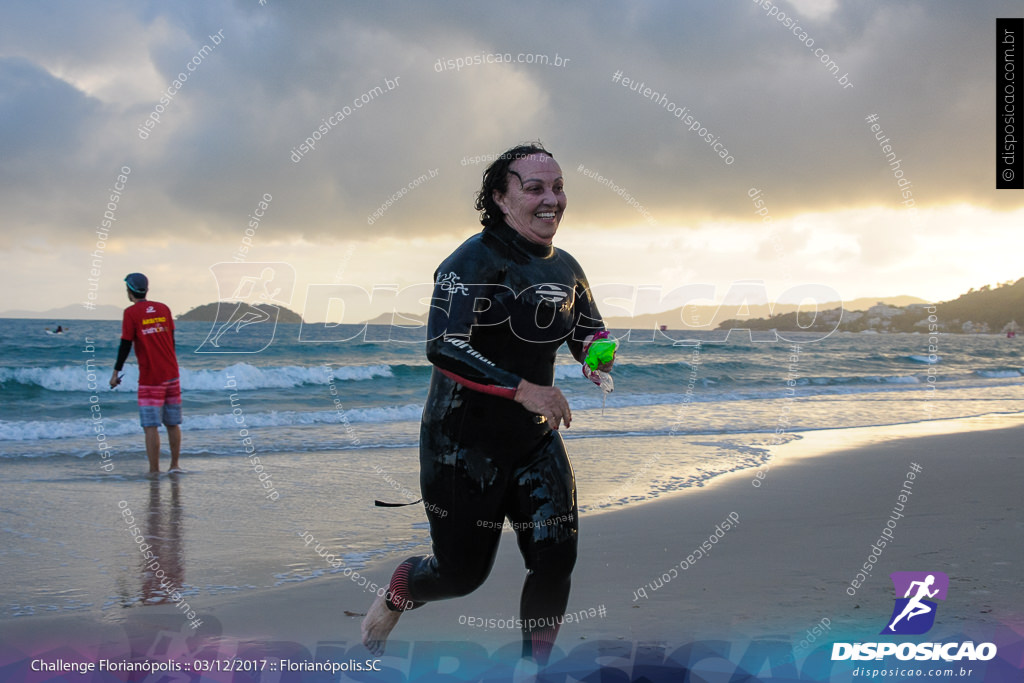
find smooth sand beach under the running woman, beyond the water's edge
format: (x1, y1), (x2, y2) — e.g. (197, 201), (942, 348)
(0, 416), (1024, 681)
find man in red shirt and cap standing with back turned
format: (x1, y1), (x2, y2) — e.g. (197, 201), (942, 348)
(111, 272), (181, 475)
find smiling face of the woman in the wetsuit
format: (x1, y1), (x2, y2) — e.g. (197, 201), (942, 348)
(494, 155), (565, 245)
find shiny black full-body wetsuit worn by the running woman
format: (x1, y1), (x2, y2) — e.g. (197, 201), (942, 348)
(389, 224), (604, 654)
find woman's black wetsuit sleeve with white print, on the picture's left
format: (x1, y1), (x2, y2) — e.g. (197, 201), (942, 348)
(427, 243), (521, 398)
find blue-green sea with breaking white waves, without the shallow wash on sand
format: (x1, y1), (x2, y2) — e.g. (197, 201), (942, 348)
(0, 319), (1024, 461)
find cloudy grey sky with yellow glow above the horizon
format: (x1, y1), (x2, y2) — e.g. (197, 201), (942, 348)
(0, 0), (1024, 322)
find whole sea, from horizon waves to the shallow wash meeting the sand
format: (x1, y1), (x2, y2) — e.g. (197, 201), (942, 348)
(0, 319), (1024, 618)
